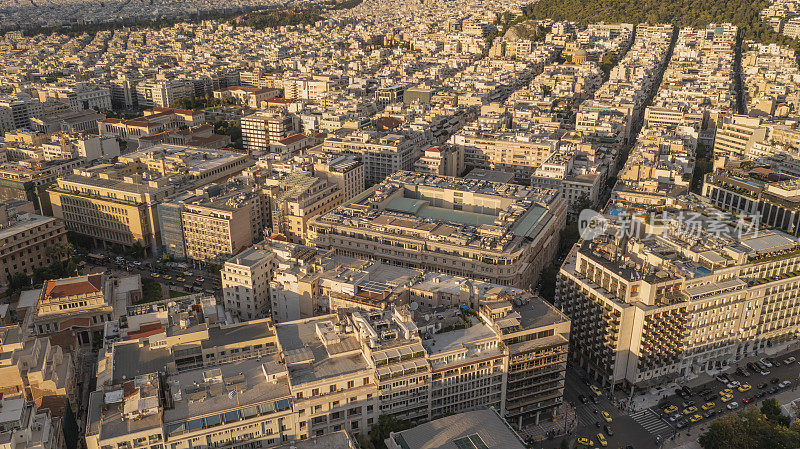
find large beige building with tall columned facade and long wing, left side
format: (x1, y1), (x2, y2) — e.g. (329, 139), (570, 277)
(48, 144), (249, 254)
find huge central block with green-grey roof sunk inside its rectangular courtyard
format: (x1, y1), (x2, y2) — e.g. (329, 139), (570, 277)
(309, 172), (566, 287)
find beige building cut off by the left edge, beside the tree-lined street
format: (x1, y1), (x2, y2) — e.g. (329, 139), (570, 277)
(0, 203), (67, 285)
